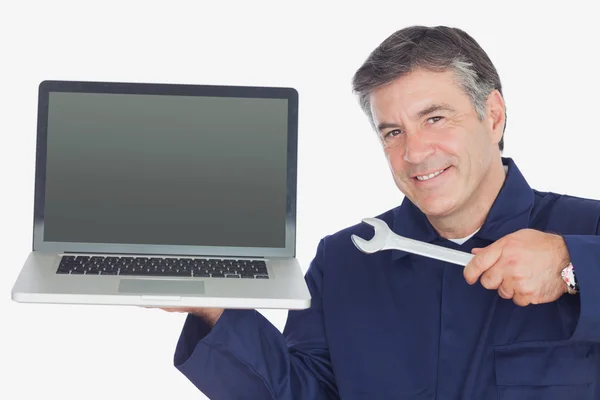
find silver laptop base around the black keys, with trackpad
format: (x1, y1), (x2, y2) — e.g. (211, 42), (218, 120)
(11, 251), (310, 310)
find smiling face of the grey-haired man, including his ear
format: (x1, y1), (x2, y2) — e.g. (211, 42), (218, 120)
(371, 70), (504, 217)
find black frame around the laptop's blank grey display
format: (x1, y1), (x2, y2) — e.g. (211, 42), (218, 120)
(33, 80), (298, 258)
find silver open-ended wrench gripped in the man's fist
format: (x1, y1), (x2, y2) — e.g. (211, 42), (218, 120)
(351, 218), (474, 266)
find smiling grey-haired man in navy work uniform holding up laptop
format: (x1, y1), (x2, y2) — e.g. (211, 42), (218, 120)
(164, 27), (600, 400)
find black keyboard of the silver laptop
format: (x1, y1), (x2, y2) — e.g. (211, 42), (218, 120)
(56, 256), (269, 279)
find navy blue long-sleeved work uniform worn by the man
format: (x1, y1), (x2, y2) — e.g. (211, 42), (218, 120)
(174, 158), (600, 400)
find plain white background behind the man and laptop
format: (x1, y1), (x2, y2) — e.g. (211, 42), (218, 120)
(0, 0), (600, 400)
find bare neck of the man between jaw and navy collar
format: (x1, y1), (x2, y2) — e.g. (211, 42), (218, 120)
(428, 158), (506, 239)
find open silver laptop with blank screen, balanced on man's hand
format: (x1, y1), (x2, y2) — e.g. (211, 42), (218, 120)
(12, 81), (310, 309)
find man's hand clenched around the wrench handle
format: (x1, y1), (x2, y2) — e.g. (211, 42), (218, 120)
(463, 229), (570, 306)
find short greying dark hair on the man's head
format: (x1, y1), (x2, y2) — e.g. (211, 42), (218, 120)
(352, 26), (506, 151)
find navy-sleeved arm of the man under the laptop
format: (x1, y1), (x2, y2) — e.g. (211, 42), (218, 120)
(174, 242), (338, 400)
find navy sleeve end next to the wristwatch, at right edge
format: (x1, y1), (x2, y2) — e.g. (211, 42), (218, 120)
(563, 225), (600, 342)
